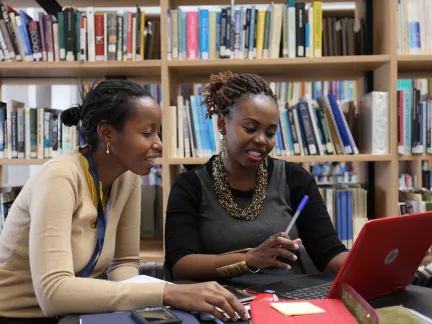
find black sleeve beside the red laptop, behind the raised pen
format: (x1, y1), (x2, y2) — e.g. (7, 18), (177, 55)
(286, 162), (347, 271)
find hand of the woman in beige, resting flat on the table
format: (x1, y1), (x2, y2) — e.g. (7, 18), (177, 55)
(163, 282), (249, 321)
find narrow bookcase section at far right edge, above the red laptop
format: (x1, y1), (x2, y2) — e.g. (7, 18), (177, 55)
(396, 0), (432, 215)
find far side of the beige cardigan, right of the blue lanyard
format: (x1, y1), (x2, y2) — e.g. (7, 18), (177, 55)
(108, 176), (141, 281)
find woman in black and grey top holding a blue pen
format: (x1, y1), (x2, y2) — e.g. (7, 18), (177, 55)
(165, 72), (347, 280)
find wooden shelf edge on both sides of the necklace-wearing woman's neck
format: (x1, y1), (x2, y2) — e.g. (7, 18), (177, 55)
(168, 154), (392, 165)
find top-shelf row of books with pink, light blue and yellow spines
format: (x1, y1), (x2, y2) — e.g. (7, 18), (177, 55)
(168, 0), (366, 60)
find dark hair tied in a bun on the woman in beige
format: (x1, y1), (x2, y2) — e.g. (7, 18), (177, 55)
(60, 79), (153, 150)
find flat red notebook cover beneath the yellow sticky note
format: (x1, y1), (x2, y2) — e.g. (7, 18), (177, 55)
(251, 299), (358, 324)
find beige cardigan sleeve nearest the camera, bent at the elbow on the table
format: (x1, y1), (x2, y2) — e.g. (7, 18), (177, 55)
(29, 162), (166, 317)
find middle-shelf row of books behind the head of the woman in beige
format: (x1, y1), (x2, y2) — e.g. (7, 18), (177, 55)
(0, 84), (162, 159)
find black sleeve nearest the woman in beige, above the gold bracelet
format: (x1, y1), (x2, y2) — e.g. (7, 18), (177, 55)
(165, 171), (201, 272)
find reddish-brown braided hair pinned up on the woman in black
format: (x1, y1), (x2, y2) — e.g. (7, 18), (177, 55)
(202, 71), (277, 118)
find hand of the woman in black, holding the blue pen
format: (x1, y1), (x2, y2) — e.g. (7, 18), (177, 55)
(245, 233), (301, 270)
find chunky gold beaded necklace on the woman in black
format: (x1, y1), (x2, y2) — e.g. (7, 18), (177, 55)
(212, 155), (268, 221)
